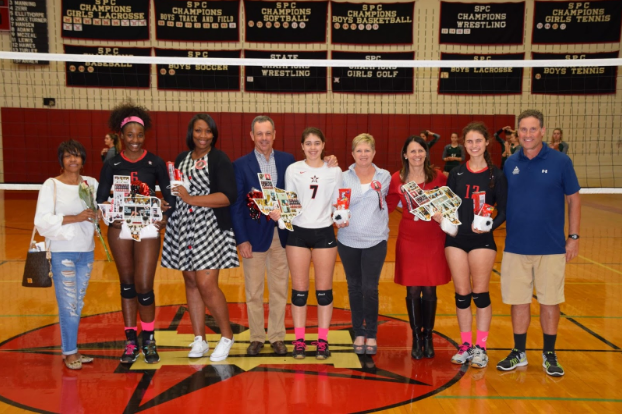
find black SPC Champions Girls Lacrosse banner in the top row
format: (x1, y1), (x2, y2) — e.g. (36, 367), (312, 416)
(61, 0), (149, 40)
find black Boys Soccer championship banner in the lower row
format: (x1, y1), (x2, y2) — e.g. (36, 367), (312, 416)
(155, 48), (240, 91)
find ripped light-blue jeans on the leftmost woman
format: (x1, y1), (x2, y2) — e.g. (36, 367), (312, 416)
(52, 251), (93, 355)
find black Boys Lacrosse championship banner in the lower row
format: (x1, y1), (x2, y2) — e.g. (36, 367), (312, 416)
(438, 53), (525, 95)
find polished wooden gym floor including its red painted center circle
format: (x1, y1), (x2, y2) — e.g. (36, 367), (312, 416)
(0, 191), (622, 413)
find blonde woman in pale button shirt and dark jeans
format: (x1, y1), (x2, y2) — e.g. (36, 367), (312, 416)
(337, 133), (391, 355)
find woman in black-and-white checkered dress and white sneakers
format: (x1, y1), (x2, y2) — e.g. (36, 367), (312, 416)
(162, 114), (240, 361)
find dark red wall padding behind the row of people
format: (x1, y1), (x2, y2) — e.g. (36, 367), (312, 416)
(1, 108), (515, 183)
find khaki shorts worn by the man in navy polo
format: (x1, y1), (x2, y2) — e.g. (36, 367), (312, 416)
(501, 252), (566, 305)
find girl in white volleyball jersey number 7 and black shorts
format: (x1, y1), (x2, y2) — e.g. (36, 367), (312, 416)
(270, 127), (342, 360)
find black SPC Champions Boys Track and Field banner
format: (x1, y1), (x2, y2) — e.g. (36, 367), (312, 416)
(154, 0), (240, 42)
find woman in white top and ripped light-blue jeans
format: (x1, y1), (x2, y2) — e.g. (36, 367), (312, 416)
(35, 140), (98, 370)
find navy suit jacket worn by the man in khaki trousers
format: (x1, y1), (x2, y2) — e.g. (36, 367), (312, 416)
(231, 150), (296, 253)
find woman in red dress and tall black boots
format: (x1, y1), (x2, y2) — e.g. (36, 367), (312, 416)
(387, 136), (451, 360)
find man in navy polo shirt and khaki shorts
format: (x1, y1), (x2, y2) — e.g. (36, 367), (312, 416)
(497, 110), (581, 377)
